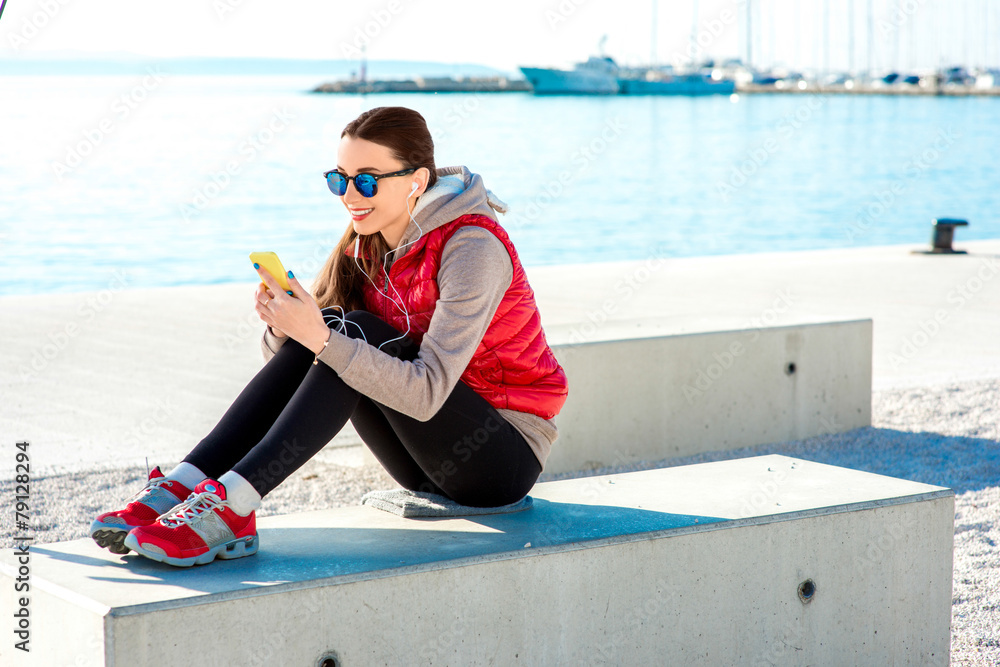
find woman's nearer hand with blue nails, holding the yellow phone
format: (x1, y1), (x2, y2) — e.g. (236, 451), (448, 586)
(256, 267), (330, 354)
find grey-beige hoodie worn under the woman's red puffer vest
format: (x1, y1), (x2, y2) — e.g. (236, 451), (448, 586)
(261, 167), (558, 466)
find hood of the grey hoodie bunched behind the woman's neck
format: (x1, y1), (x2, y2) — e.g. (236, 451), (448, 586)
(393, 167), (507, 261)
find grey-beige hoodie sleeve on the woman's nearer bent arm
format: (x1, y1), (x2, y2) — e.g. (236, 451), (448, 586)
(319, 226), (514, 421)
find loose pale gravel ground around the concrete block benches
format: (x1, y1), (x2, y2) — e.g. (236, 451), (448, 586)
(0, 379), (1000, 666)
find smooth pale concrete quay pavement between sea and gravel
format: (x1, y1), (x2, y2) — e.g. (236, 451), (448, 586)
(0, 240), (1000, 475)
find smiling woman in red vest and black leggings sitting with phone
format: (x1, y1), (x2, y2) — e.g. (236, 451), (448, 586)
(91, 107), (567, 566)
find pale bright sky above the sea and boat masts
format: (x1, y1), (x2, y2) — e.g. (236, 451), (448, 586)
(0, 0), (1000, 71)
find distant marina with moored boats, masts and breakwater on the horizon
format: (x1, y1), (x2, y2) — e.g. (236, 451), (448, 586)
(312, 0), (1000, 96)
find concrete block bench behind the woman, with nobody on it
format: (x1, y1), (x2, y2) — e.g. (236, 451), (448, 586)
(544, 319), (872, 473)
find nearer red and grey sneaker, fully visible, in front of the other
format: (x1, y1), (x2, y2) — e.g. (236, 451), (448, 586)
(124, 479), (259, 567)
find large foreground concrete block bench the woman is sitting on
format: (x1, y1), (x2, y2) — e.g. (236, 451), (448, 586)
(0, 455), (954, 667)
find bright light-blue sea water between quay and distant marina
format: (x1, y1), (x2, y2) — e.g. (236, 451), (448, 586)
(0, 71), (1000, 294)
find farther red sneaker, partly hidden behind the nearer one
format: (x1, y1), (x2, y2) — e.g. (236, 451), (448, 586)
(90, 466), (191, 554)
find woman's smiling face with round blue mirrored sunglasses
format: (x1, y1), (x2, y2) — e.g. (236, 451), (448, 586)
(337, 135), (428, 249)
